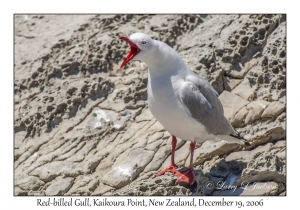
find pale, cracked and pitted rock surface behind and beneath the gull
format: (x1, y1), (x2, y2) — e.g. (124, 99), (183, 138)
(14, 14), (286, 196)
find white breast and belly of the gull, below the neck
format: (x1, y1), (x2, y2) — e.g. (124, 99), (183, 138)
(148, 72), (212, 142)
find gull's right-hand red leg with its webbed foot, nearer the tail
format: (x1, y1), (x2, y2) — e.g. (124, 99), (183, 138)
(175, 142), (196, 185)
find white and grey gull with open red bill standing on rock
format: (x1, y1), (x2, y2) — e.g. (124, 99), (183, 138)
(119, 33), (243, 185)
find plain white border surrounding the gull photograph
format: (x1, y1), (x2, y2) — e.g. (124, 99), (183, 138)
(4, 0), (300, 209)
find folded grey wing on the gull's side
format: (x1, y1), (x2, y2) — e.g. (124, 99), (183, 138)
(179, 75), (235, 135)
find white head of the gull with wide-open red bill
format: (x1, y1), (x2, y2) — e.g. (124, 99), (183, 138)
(119, 33), (154, 68)
